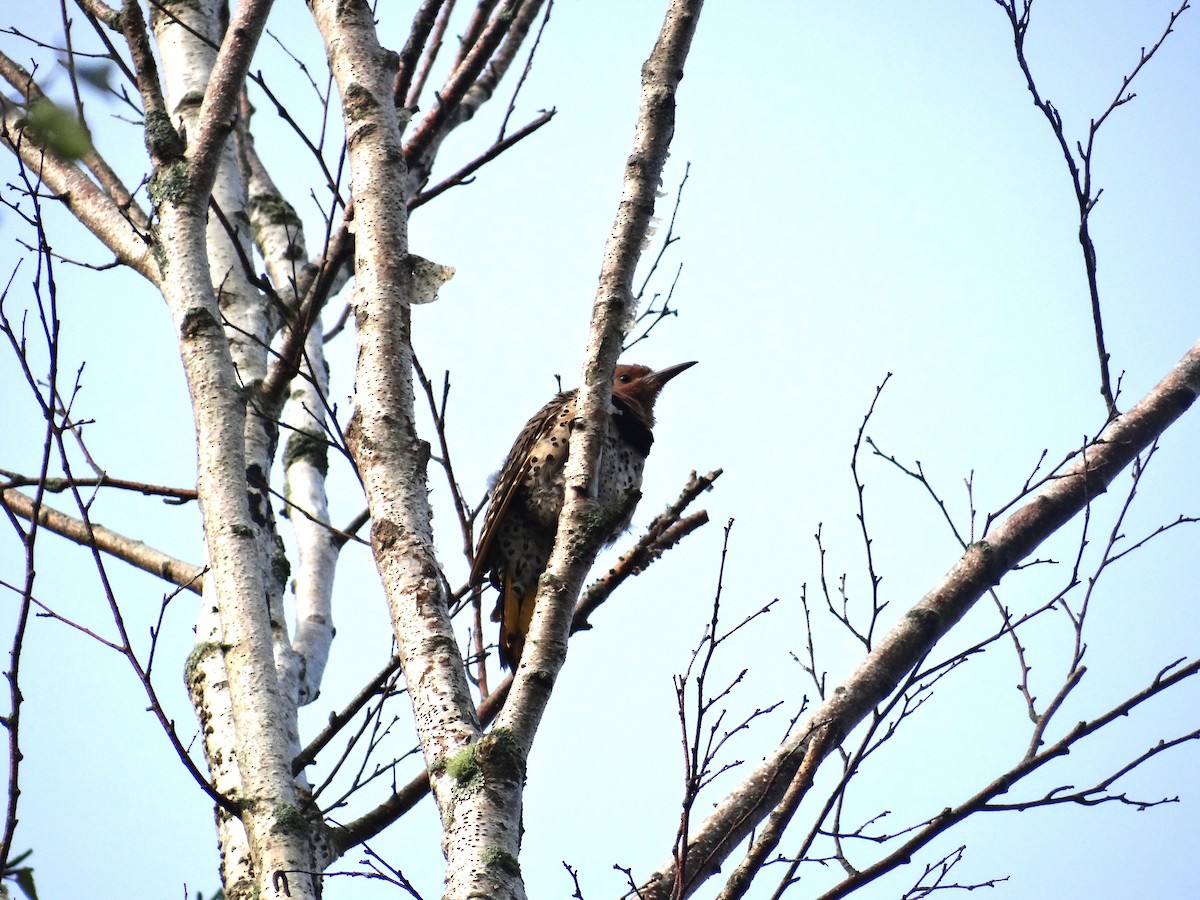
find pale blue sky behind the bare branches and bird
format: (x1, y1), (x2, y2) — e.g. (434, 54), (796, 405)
(0, 0), (1200, 900)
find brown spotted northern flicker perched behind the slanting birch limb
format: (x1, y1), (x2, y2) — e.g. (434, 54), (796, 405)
(470, 362), (696, 670)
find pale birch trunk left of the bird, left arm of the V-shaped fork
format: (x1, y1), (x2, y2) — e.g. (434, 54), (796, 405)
(312, 0), (494, 898)
